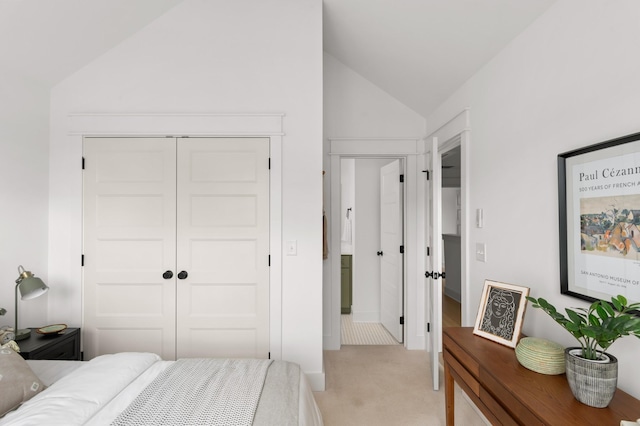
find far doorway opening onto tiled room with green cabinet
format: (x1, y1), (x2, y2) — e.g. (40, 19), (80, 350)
(340, 158), (405, 345)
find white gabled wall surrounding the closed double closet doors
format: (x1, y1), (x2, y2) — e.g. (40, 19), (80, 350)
(49, 0), (324, 388)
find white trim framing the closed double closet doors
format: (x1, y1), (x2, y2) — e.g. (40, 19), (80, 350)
(65, 112), (285, 359)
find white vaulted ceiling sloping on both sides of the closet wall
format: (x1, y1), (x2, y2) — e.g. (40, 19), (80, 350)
(0, 0), (555, 117)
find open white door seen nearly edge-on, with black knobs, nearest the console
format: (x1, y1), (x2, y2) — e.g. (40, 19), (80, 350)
(426, 138), (442, 390)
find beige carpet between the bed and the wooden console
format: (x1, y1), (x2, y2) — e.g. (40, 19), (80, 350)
(314, 345), (486, 426)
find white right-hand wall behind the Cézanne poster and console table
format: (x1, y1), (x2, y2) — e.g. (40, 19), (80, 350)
(427, 0), (640, 397)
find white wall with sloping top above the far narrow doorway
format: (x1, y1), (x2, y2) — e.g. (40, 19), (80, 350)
(323, 53), (425, 348)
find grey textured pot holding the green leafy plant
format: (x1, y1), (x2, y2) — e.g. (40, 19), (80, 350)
(565, 348), (618, 408)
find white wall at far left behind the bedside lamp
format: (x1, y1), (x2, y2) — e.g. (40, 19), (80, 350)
(0, 72), (49, 328)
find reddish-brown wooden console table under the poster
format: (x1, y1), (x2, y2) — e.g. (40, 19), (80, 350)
(443, 327), (640, 426)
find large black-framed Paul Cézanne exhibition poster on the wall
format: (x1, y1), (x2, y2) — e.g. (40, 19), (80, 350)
(558, 133), (640, 303)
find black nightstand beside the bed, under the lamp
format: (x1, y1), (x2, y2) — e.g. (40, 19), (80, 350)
(16, 328), (82, 361)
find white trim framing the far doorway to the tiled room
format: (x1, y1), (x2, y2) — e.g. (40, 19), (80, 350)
(323, 138), (425, 350)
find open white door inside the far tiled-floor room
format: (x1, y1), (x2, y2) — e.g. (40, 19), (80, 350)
(379, 160), (403, 342)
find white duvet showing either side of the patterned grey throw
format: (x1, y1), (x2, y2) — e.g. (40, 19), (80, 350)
(0, 353), (322, 426)
